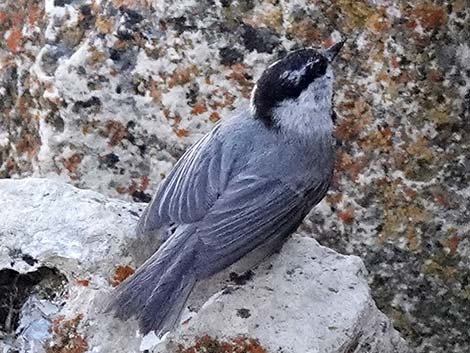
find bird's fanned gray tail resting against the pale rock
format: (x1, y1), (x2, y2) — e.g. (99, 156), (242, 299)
(106, 229), (197, 336)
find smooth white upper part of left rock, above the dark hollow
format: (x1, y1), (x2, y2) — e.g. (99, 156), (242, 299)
(0, 178), (145, 281)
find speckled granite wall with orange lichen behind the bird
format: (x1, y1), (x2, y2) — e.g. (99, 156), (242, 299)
(0, 0), (470, 353)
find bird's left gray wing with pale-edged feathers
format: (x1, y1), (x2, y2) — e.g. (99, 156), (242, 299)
(137, 125), (230, 234)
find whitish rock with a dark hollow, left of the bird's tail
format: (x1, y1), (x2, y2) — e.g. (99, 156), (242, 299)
(0, 178), (144, 353)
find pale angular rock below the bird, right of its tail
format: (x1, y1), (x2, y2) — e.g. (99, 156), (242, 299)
(154, 236), (409, 353)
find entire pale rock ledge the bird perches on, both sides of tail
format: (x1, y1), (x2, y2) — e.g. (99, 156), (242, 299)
(0, 178), (410, 353)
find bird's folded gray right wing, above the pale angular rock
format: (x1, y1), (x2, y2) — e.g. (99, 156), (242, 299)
(195, 176), (329, 277)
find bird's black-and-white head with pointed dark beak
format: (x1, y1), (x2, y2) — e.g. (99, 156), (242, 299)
(251, 41), (344, 128)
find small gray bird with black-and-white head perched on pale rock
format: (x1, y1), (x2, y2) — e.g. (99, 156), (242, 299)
(106, 41), (344, 337)
